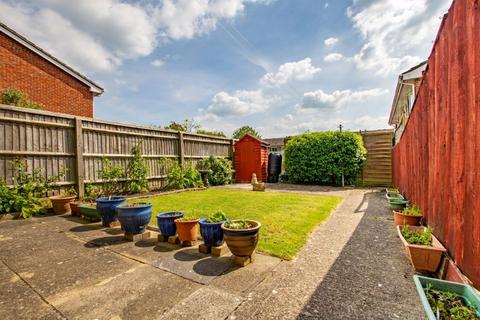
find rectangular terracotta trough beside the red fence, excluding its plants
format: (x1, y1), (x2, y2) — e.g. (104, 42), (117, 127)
(397, 226), (447, 272)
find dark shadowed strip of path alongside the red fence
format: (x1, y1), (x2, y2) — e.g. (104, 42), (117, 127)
(297, 192), (423, 319)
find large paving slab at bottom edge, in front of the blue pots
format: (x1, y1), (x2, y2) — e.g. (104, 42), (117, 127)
(49, 264), (201, 319)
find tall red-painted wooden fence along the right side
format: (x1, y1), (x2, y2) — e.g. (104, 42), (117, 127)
(393, 0), (480, 289)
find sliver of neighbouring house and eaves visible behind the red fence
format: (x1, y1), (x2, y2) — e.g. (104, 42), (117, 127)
(388, 60), (427, 125)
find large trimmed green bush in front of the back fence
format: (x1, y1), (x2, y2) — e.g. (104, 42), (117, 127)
(285, 131), (366, 185)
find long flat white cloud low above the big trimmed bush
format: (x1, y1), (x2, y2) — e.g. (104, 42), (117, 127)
(300, 88), (388, 109)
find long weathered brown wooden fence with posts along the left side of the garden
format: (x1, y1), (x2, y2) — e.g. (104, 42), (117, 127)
(0, 105), (233, 196)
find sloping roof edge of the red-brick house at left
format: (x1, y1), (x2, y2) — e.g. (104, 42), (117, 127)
(0, 22), (104, 96)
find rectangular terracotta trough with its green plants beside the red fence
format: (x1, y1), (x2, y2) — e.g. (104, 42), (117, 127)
(397, 226), (447, 272)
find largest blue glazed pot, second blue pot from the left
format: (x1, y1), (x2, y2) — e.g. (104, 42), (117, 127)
(117, 203), (152, 234)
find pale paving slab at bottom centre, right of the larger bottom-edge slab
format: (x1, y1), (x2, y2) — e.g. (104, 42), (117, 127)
(160, 286), (242, 320)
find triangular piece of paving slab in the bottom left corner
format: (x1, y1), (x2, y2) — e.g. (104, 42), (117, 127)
(0, 263), (62, 320)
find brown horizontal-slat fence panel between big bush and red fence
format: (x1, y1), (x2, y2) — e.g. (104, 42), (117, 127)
(360, 129), (393, 186)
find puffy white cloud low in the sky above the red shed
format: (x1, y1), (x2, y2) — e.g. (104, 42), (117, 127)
(207, 90), (274, 117)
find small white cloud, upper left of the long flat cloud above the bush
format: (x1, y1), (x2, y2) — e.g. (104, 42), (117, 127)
(260, 58), (321, 86)
